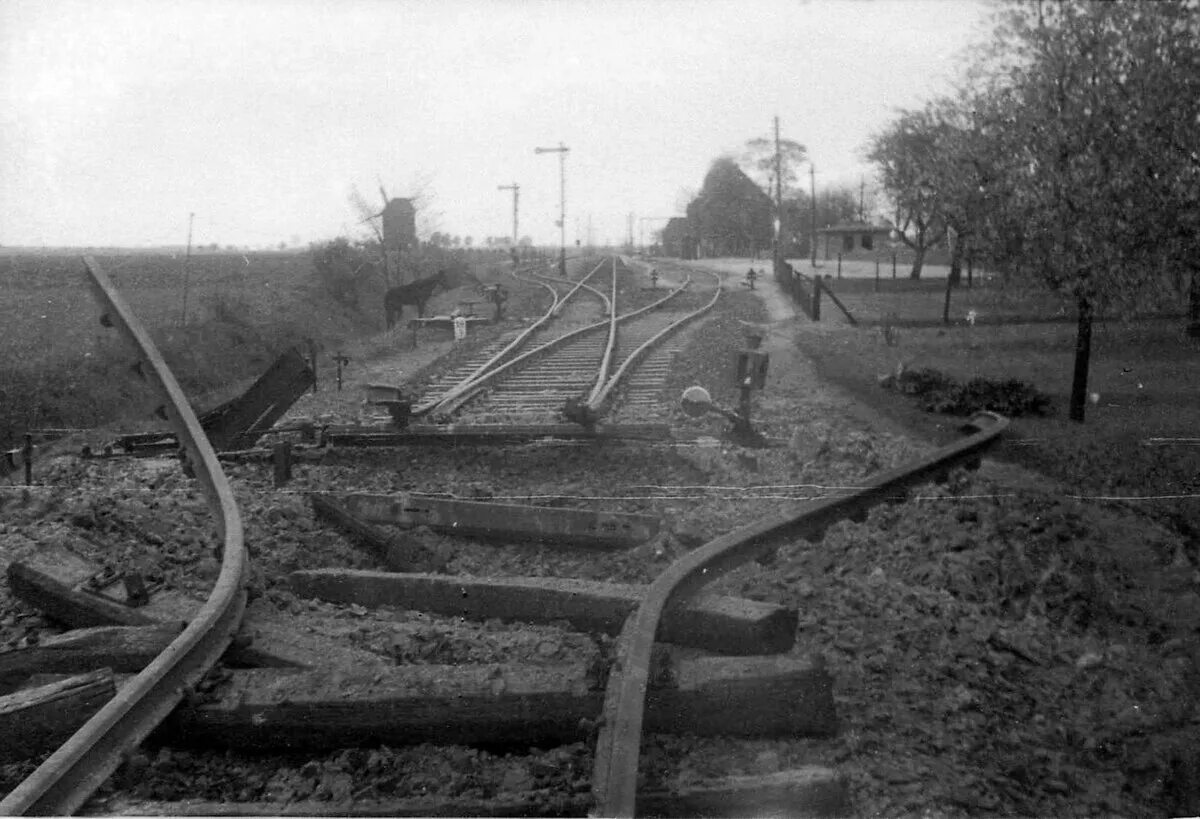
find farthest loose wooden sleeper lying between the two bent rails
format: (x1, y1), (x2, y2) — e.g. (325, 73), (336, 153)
(332, 492), (659, 549)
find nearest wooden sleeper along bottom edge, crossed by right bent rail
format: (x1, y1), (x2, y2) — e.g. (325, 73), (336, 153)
(98, 765), (850, 819)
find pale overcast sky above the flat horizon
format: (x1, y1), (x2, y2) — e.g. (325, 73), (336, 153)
(0, 0), (991, 247)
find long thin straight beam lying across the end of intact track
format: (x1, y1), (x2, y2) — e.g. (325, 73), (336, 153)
(324, 424), (672, 447)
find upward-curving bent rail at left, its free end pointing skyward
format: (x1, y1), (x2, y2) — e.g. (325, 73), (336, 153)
(0, 256), (247, 815)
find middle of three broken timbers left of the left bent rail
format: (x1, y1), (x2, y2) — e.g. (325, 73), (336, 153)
(0, 623), (182, 692)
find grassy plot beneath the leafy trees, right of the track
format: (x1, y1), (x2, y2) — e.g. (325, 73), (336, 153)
(798, 283), (1200, 557)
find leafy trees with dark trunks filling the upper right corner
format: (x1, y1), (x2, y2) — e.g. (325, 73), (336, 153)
(866, 0), (1200, 420)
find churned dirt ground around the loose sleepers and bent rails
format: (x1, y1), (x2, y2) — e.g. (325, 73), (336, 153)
(0, 253), (1200, 817)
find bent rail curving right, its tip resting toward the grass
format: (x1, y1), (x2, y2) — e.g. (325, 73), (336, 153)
(592, 412), (1008, 817)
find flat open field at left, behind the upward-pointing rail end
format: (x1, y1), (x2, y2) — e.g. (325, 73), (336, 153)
(0, 252), (382, 446)
